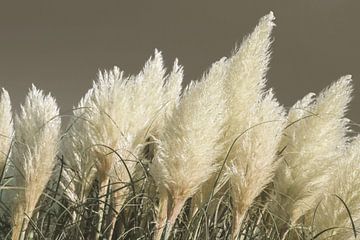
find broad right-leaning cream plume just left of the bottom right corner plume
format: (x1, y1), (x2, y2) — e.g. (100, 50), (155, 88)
(274, 76), (352, 234)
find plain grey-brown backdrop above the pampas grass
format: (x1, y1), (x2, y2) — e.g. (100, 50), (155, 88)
(0, 0), (360, 122)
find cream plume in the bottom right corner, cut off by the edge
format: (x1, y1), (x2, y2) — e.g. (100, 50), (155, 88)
(306, 135), (360, 240)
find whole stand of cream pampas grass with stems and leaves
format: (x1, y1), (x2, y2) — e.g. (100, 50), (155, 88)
(0, 12), (360, 240)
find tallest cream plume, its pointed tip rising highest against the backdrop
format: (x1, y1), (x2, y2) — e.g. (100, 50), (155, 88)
(225, 12), (275, 119)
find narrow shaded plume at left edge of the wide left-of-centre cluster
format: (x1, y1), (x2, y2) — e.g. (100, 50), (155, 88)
(60, 86), (96, 203)
